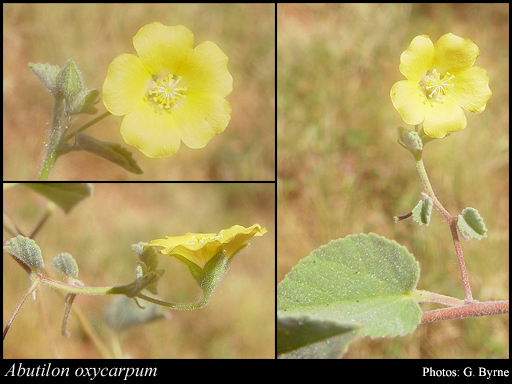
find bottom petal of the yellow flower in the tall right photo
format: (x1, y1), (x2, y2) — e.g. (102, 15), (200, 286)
(423, 98), (467, 139)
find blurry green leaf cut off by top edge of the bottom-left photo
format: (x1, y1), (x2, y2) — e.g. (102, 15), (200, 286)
(22, 183), (93, 213)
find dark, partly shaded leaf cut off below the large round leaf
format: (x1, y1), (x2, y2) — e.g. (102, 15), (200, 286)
(277, 316), (360, 359)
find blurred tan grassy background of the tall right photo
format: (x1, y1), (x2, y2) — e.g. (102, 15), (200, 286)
(277, 4), (509, 358)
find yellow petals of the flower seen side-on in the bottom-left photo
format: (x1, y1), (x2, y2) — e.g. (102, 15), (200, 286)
(147, 224), (267, 268)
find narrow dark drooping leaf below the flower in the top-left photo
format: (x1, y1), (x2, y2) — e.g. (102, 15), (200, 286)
(73, 133), (143, 175)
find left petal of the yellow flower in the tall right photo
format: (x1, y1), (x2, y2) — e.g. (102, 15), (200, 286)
(391, 80), (428, 125)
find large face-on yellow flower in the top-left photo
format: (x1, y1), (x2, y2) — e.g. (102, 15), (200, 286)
(103, 22), (233, 157)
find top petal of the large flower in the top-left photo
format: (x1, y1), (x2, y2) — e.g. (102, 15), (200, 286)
(133, 22), (194, 76)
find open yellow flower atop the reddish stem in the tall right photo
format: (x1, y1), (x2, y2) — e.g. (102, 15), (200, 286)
(391, 33), (492, 138)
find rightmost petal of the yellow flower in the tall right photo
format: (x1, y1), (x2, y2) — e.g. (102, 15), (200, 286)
(450, 67), (492, 113)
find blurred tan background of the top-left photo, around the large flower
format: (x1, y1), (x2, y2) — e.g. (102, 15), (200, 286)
(3, 4), (275, 181)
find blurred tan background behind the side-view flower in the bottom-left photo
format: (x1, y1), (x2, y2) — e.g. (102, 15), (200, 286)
(3, 183), (275, 359)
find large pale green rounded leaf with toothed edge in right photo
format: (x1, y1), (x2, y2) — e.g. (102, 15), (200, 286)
(277, 234), (422, 358)
